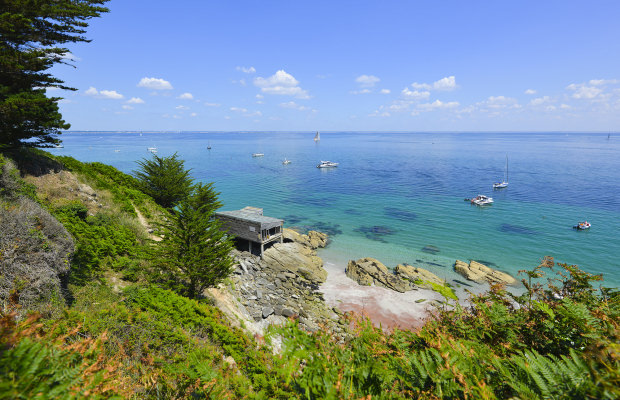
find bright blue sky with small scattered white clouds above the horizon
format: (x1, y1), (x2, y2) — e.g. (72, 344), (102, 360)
(49, 0), (620, 132)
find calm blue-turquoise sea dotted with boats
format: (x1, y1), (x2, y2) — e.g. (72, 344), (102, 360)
(50, 132), (620, 286)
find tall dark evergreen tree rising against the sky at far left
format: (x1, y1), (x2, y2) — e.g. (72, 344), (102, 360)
(0, 0), (108, 149)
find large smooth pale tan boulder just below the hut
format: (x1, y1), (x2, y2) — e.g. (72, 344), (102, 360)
(263, 242), (327, 284)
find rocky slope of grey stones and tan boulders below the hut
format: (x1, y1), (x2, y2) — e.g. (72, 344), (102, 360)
(210, 230), (346, 334)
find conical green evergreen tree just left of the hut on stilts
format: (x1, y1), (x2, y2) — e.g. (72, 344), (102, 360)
(154, 184), (233, 298)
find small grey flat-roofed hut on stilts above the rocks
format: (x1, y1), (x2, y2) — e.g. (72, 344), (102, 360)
(215, 207), (284, 257)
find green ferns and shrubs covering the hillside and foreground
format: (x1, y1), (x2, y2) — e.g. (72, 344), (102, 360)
(0, 151), (620, 399)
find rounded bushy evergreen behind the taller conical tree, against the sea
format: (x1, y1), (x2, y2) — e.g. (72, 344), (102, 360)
(134, 153), (193, 209)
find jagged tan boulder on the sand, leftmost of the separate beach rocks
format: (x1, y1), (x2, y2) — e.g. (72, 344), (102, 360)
(345, 257), (413, 293)
